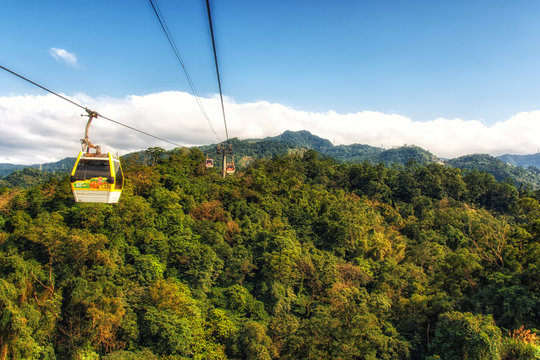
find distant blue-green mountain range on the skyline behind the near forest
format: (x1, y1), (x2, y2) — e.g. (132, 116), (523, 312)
(0, 130), (540, 188)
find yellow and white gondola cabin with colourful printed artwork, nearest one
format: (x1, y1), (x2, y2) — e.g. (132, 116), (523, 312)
(70, 152), (124, 204)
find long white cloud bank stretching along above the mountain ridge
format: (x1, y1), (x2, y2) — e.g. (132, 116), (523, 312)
(0, 91), (540, 164)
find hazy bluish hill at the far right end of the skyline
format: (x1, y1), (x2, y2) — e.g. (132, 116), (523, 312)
(446, 154), (540, 187)
